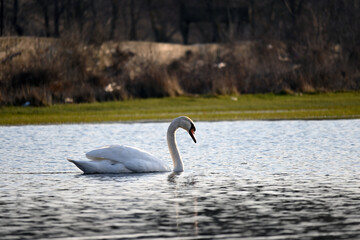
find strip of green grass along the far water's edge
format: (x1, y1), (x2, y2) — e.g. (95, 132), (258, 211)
(0, 92), (360, 125)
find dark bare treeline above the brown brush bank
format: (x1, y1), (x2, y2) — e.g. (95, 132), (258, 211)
(0, 0), (360, 44)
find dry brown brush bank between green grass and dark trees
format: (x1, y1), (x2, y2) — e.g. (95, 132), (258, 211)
(0, 38), (360, 106)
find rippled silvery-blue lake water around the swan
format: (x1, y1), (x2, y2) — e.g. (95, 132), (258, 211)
(0, 120), (360, 240)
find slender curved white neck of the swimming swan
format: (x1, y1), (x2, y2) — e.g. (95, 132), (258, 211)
(167, 123), (184, 172)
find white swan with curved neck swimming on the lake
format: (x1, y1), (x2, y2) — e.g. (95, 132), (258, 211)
(67, 116), (196, 174)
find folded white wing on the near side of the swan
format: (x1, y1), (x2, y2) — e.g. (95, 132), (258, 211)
(86, 145), (170, 172)
